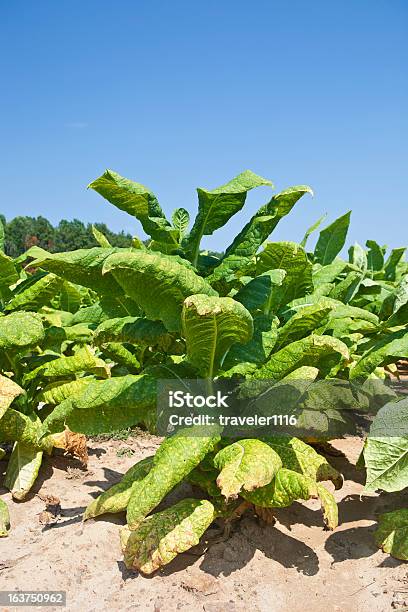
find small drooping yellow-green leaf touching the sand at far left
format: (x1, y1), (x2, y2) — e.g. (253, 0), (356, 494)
(4, 442), (43, 501)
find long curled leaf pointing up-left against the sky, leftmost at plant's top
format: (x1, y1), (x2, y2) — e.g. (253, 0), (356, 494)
(88, 170), (177, 247)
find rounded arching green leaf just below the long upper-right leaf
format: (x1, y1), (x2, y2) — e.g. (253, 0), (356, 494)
(256, 242), (313, 312)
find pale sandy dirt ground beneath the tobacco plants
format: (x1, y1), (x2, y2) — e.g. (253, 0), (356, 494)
(0, 436), (408, 612)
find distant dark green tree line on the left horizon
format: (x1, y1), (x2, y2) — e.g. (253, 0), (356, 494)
(0, 215), (132, 257)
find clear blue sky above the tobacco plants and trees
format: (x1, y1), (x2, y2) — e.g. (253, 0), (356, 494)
(0, 0), (408, 248)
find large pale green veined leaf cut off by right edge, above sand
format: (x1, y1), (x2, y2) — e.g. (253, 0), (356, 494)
(364, 399), (408, 492)
